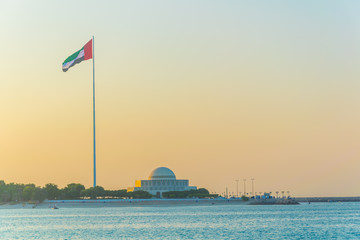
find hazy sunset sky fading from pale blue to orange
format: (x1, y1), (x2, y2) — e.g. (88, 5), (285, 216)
(0, 0), (360, 196)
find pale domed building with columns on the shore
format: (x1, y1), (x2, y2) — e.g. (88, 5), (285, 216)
(127, 167), (197, 198)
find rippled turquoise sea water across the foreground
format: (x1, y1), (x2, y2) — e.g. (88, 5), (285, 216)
(0, 203), (360, 239)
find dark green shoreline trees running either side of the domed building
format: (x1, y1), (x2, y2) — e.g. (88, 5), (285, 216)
(0, 180), (218, 203)
